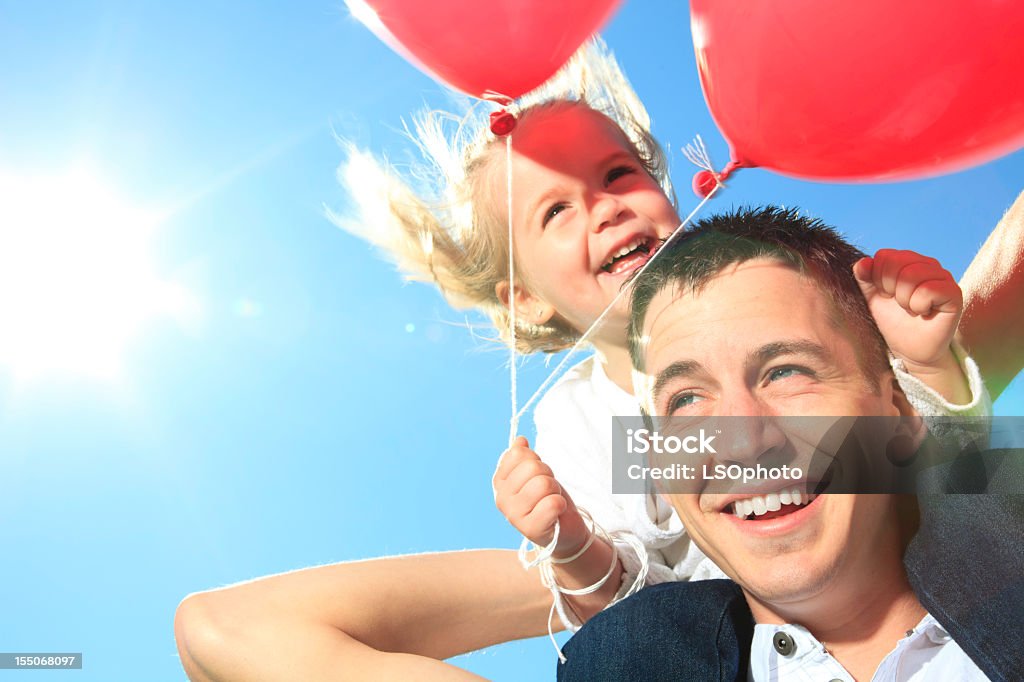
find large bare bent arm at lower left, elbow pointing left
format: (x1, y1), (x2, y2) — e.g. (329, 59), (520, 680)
(174, 550), (551, 682)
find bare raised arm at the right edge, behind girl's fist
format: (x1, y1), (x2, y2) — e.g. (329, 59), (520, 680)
(959, 188), (1024, 400)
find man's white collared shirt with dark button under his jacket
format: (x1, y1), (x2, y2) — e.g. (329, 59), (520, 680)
(749, 614), (988, 682)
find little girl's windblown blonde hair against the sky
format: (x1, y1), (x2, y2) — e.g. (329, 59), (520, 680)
(329, 39), (674, 353)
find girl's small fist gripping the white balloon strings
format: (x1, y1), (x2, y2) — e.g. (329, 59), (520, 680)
(492, 436), (590, 558)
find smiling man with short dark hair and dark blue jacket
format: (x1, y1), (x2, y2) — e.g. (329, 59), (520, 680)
(559, 209), (1024, 680)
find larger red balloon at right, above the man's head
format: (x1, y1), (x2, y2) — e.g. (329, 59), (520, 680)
(690, 0), (1024, 181)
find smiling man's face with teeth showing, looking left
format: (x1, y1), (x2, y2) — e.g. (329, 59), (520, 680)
(643, 259), (899, 604)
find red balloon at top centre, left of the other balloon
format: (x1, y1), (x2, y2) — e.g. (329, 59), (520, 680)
(346, 0), (620, 98)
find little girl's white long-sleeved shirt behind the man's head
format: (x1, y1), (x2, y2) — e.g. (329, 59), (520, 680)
(534, 346), (991, 632)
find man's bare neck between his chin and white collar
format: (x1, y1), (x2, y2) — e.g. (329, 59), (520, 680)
(748, 562), (926, 681)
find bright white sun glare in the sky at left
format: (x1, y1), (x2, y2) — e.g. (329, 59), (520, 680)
(0, 162), (194, 380)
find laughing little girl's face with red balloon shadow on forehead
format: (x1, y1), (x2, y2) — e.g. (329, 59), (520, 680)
(493, 104), (679, 343)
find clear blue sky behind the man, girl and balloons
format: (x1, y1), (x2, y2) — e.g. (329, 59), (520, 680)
(0, 0), (1024, 682)
